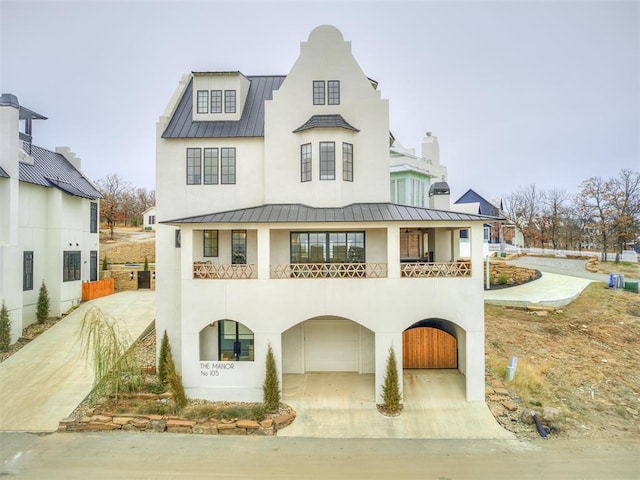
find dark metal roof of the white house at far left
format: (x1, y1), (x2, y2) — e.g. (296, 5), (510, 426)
(18, 145), (102, 199)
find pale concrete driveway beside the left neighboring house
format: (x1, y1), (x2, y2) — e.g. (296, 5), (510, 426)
(0, 290), (155, 432)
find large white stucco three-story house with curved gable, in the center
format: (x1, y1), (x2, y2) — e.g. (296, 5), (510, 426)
(156, 26), (486, 402)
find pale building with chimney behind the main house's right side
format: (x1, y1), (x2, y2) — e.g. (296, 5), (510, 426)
(390, 132), (447, 207)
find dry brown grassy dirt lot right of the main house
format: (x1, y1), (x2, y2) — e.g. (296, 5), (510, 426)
(485, 283), (640, 438)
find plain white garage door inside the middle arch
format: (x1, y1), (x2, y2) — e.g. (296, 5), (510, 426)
(304, 319), (360, 372)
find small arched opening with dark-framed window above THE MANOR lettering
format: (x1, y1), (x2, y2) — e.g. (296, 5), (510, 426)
(199, 320), (254, 362)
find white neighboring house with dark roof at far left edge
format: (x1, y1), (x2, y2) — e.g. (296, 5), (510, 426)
(0, 94), (101, 342)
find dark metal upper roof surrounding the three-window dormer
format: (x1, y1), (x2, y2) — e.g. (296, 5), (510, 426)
(162, 75), (286, 138)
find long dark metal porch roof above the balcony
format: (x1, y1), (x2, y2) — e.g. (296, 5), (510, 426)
(160, 203), (499, 224)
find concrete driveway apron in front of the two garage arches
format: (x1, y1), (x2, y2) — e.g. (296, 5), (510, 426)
(278, 370), (515, 439)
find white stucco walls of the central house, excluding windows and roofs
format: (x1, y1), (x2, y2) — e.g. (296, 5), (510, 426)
(156, 27), (484, 401)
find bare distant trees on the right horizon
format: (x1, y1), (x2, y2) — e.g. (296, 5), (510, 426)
(503, 168), (640, 261)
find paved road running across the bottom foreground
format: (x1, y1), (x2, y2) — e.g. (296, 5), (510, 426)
(0, 433), (640, 480)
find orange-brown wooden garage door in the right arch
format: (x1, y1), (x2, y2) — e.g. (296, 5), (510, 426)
(402, 327), (458, 368)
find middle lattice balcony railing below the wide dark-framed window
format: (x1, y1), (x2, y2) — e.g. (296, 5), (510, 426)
(271, 263), (387, 278)
